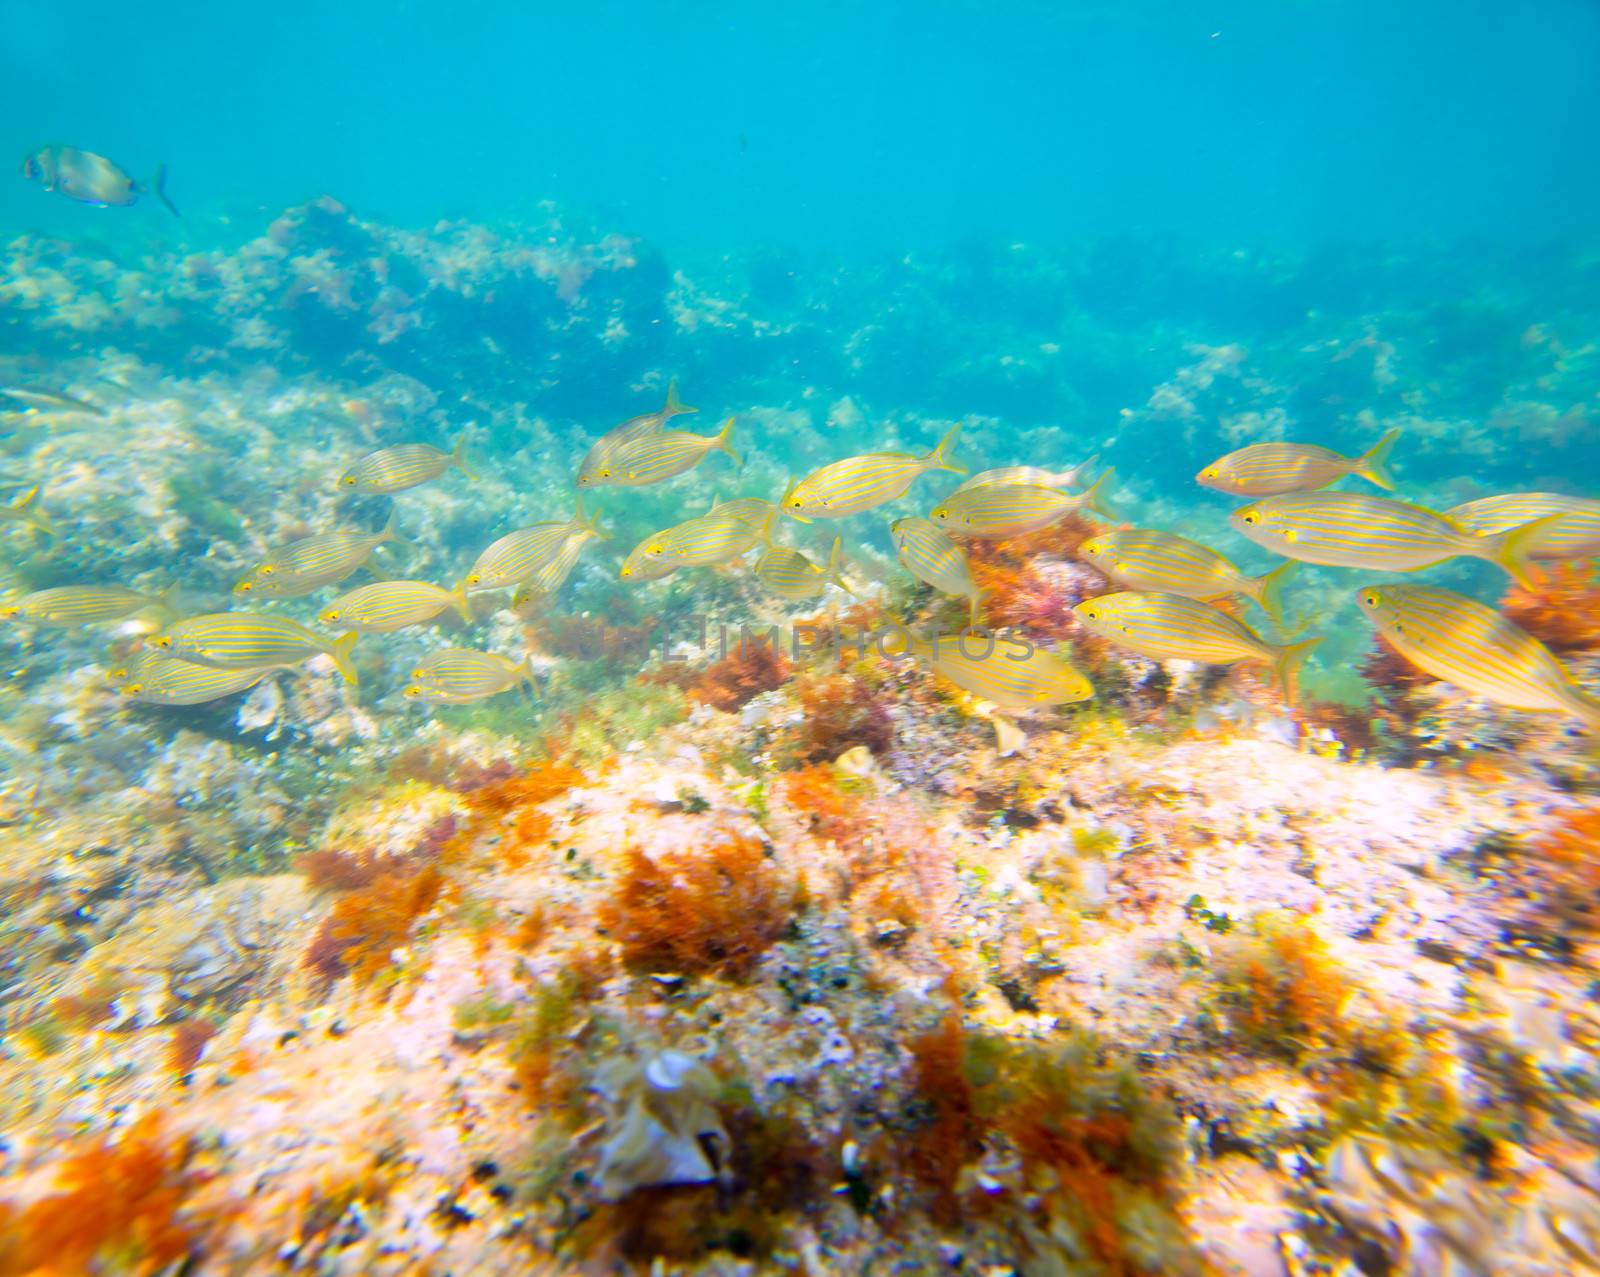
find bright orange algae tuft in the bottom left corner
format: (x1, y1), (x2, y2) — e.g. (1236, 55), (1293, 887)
(0, 1117), (205, 1277)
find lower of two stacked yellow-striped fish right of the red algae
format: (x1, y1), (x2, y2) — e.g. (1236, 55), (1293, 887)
(1072, 590), (1322, 701)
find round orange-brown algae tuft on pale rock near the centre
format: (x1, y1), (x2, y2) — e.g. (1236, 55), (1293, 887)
(600, 832), (797, 978)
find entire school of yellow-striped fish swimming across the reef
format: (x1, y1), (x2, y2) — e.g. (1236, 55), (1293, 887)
(0, 364), (1600, 754)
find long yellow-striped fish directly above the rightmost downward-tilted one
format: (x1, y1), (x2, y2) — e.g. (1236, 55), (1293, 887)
(1229, 493), (1546, 586)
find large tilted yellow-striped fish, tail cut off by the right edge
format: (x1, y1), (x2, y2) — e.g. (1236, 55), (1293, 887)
(1355, 584), (1600, 731)
